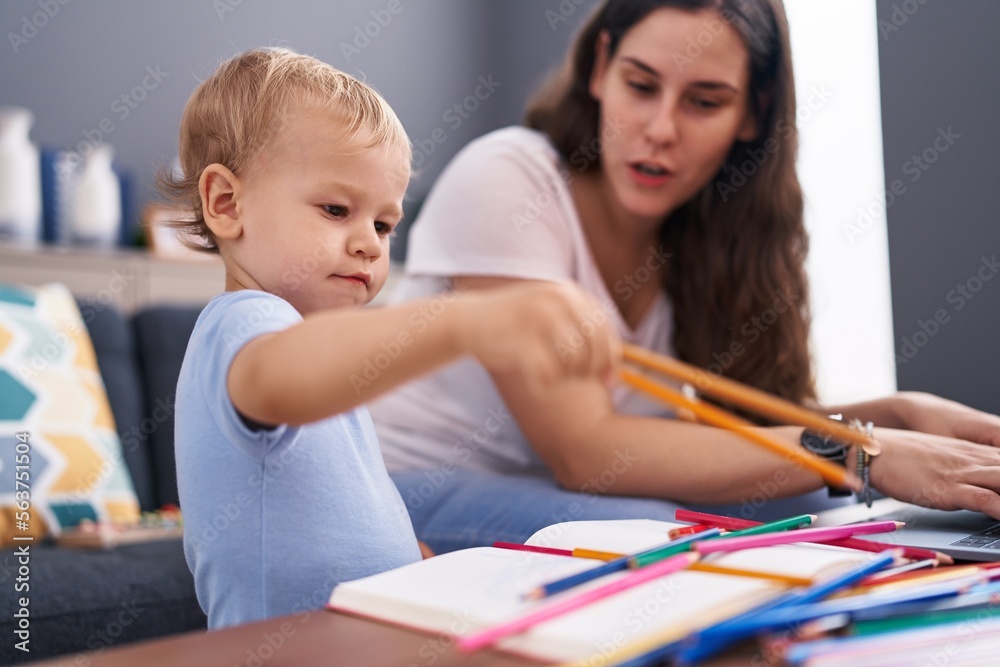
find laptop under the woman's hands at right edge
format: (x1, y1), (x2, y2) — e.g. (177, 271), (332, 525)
(813, 498), (1000, 561)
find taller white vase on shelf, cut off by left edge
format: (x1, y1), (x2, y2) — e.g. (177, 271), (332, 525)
(0, 106), (42, 246)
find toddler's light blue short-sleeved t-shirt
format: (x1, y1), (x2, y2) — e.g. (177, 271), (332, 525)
(175, 290), (420, 629)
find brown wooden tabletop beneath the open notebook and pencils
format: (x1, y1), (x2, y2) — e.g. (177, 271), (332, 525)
(31, 611), (752, 667)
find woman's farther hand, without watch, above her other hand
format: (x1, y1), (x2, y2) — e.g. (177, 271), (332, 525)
(894, 392), (1000, 447)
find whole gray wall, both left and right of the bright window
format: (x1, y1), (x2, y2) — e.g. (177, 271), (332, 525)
(0, 0), (1000, 412)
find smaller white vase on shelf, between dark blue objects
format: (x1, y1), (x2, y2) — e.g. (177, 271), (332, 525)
(71, 143), (122, 248)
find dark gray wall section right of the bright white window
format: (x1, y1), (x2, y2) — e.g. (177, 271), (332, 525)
(880, 0), (1000, 413)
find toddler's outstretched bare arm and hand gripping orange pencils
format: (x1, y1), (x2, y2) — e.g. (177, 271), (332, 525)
(227, 282), (620, 424)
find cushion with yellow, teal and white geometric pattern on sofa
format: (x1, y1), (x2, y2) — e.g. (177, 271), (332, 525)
(0, 284), (139, 544)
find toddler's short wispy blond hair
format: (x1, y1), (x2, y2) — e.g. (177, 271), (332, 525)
(158, 48), (411, 253)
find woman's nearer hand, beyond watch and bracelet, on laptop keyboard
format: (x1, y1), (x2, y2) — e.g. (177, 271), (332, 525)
(871, 428), (1000, 520)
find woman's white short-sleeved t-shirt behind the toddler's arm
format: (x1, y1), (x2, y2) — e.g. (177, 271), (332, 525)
(369, 127), (672, 483)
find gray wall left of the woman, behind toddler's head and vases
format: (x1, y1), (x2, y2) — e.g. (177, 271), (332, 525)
(0, 0), (596, 250)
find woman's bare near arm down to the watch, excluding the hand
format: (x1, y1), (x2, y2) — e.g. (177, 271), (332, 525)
(454, 277), (822, 502)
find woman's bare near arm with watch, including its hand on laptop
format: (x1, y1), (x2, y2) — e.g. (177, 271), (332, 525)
(455, 277), (1000, 519)
